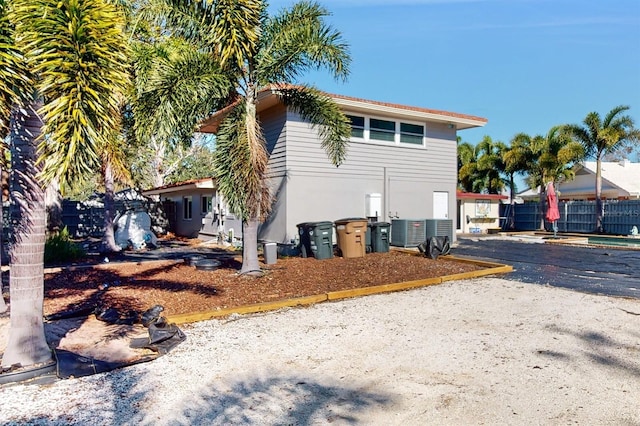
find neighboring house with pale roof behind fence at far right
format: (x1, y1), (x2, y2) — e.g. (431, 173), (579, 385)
(518, 160), (640, 201)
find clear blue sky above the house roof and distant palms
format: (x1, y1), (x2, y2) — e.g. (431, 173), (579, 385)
(269, 0), (640, 161)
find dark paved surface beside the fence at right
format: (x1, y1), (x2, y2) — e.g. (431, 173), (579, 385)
(452, 236), (640, 299)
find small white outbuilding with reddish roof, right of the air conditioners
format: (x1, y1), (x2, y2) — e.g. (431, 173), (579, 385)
(456, 191), (509, 234)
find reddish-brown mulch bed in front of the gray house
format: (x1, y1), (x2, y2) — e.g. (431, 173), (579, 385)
(44, 251), (482, 315)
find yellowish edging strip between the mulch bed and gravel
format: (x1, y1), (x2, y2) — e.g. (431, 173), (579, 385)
(167, 255), (513, 324)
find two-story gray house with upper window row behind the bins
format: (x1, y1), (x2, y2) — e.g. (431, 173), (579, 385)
(144, 88), (487, 242)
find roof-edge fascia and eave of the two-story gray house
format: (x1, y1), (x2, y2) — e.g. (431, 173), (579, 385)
(199, 84), (488, 134)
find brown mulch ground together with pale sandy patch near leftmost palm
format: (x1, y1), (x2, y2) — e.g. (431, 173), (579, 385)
(0, 250), (481, 362)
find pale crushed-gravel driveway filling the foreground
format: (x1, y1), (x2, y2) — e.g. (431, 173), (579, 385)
(0, 278), (640, 425)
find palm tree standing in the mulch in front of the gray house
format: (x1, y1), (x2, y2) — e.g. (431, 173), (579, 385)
(158, 0), (350, 274)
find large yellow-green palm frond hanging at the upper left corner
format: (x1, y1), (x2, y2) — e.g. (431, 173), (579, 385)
(14, 0), (128, 184)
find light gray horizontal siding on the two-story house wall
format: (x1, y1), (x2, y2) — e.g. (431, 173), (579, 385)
(261, 111), (456, 242)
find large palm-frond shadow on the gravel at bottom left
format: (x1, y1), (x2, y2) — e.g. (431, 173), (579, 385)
(3, 369), (393, 425)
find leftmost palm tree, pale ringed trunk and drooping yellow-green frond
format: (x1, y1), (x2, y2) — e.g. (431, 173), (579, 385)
(0, 0), (128, 367)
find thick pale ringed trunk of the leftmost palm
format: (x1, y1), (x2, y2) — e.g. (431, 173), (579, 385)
(2, 104), (51, 367)
